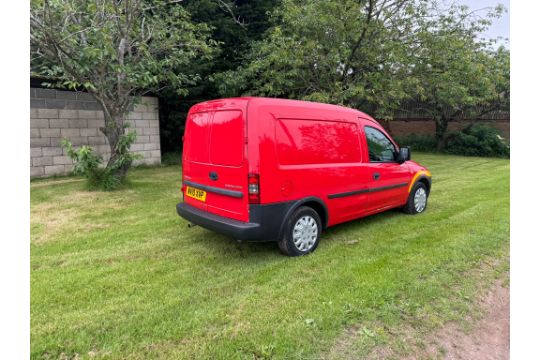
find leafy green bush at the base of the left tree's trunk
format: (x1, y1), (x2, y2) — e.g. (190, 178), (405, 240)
(62, 131), (141, 191)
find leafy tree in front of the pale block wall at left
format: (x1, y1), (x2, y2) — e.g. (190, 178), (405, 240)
(30, 0), (215, 180)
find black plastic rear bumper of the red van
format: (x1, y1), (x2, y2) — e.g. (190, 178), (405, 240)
(176, 202), (294, 241)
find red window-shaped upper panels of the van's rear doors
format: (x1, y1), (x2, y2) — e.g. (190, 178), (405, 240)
(185, 110), (244, 166)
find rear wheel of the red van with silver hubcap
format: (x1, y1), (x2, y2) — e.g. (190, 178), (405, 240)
(278, 206), (322, 256)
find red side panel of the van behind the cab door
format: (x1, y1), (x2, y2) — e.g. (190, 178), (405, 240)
(248, 100), (369, 225)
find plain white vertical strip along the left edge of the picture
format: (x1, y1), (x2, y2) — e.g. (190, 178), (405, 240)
(0, 1), (30, 359)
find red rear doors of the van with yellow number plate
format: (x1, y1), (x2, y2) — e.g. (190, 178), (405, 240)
(182, 106), (249, 221)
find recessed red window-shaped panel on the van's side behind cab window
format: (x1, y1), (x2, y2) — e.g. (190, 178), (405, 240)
(276, 119), (360, 165)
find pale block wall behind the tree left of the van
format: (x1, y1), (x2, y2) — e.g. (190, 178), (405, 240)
(30, 88), (161, 177)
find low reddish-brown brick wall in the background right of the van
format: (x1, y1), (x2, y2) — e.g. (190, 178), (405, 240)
(381, 119), (510, 140)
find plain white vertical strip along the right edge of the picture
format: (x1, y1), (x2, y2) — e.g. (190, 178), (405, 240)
(510, 0), (540, 359)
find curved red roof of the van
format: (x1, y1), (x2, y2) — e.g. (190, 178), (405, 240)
(190, 96), (377, 123)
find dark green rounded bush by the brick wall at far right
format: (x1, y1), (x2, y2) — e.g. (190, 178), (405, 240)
(446, 124), (510, 157)
